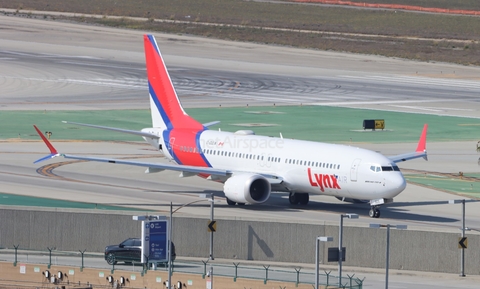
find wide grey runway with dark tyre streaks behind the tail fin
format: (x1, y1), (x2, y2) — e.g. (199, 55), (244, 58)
(0, 16), (480, 117)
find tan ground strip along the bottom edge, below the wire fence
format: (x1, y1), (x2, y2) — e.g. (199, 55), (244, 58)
(0, 262), (322, 289)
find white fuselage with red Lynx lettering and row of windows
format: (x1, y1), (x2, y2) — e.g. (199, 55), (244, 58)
(153, 130), (406, 200)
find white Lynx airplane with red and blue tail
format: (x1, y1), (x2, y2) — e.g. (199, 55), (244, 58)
(34, 35), (428, 218)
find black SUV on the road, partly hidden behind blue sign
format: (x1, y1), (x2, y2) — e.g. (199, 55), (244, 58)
(105, 238), (177, 265)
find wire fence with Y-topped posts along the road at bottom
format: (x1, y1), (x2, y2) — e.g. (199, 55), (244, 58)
(0, 246), (363, 289)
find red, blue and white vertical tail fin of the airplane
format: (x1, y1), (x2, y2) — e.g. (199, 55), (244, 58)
(144, 35), (204, 130)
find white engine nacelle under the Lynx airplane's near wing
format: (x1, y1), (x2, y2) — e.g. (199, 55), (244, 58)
(223, 174), (272, 204)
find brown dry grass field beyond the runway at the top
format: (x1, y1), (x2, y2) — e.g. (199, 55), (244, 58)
(0, 0), (480, 65)
